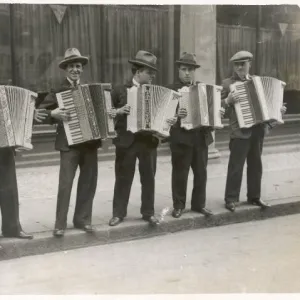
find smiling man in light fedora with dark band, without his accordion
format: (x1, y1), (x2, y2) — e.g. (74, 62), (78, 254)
(46, 48), (101, 237)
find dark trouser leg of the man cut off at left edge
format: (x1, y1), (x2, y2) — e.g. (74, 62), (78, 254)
(0, 148), (22, 235)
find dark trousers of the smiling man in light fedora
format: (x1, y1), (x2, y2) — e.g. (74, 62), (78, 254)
(55, 148), (98, 229)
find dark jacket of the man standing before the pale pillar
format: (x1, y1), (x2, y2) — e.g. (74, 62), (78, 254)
(167, 81), (214, 146)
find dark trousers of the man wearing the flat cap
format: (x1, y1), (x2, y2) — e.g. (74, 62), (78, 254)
(225, 127), (264, 203)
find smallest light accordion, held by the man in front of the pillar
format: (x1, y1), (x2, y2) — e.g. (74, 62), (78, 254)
(179, 83), (223, 130)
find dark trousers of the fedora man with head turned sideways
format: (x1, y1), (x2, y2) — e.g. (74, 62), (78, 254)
(113, 141), (157, 218)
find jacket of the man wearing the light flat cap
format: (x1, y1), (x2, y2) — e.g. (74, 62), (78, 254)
(221, 74), (272, 139)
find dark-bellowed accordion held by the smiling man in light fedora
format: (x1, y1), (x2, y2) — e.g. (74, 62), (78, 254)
(56, 83), (116, 145)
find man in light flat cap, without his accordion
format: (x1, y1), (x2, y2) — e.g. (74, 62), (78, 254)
(222, 51), (286, 212)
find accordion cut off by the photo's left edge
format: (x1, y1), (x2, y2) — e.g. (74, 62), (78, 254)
(0, 85), (37, 150)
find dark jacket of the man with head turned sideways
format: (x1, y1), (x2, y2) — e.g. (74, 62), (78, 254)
(111, 81), (158, 148)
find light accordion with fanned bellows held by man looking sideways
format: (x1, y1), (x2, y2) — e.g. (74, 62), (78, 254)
(127, 84), (180, 138)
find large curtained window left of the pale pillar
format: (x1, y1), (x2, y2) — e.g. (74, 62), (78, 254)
(0, 4), (179, 92)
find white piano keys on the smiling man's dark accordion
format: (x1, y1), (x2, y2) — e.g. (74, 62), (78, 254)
(61, 91), (82, 143)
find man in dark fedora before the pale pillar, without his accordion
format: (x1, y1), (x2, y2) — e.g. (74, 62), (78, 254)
(169, 52), (220, 218)
